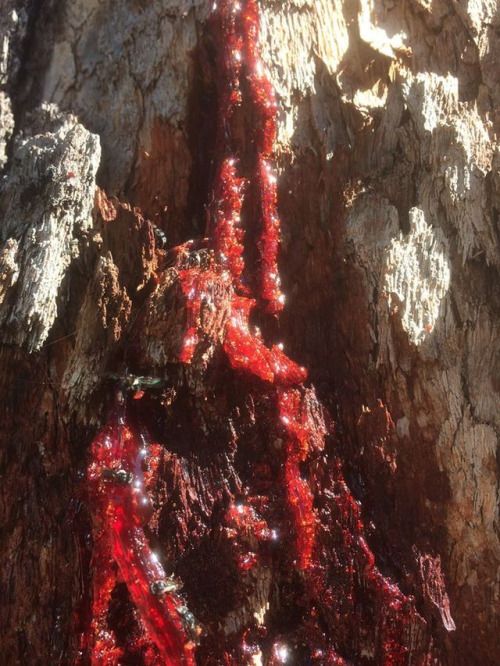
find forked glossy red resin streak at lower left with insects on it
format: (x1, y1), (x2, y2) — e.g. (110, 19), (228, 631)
(84, 408), (195, 666)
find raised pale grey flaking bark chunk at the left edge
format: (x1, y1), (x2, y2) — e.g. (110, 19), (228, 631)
(0, 106), (101, 351)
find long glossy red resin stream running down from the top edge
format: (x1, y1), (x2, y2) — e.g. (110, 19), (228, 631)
(175, 0), (430, 665)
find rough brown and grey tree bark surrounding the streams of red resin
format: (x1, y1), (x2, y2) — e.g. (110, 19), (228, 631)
(0, 0), (500, 666)
